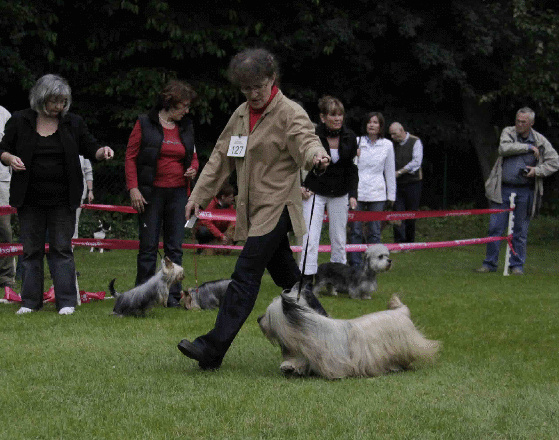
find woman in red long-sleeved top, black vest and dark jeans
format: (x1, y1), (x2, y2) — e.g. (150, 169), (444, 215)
(125, 80), (198, 307)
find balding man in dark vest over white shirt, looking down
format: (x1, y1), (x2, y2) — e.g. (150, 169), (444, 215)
(388, 122), (423, 243)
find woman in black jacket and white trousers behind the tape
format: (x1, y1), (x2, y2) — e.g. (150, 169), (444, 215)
(299, 96), (358, 283)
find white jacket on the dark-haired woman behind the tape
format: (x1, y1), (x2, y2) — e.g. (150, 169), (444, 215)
(356, 136), (396, 202)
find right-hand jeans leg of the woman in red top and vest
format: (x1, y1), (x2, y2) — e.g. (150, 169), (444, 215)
(163, 188), (188, 306)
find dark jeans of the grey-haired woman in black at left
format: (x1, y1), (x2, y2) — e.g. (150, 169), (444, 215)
(17, 206), (78, 310)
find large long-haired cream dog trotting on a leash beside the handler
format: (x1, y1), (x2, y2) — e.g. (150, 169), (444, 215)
(258, 289), (440, 379)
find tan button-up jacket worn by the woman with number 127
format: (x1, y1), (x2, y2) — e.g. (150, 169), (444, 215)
(189, 91), (326, 240)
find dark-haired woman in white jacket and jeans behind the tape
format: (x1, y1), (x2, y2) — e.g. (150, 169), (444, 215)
(348, 112), (396, 266)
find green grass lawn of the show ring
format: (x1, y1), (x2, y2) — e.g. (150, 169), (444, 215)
(0, 219), (559, 440)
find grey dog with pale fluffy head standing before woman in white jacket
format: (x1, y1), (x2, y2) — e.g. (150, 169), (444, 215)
(313, 244), (392, 299)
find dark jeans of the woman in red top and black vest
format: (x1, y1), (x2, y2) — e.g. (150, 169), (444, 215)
(136, 187), (188, 301)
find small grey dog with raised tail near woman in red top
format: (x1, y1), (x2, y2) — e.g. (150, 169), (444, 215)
(109, 257), (184, 316)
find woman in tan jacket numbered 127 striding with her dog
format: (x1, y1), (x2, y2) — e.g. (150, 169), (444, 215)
(178, 49), (330, 369)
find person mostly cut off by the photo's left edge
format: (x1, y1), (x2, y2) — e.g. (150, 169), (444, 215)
(0, 106), (15, 287)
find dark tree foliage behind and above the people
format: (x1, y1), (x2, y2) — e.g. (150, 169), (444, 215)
(0, 0), (559, 206)
